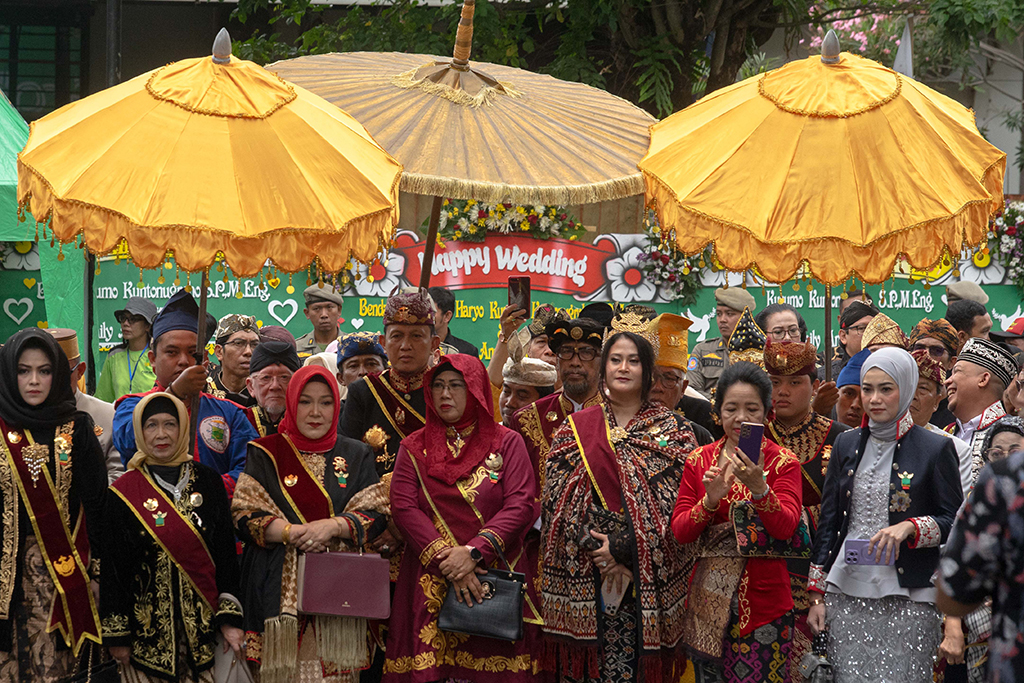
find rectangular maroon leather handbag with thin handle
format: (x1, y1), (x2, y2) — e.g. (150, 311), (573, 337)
(298, 524), (391, 620)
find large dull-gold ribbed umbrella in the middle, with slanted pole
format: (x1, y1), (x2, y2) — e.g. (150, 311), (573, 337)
(267, 0), (654, 286)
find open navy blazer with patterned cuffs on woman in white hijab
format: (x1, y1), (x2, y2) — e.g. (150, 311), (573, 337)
(809, 425), (964, 592)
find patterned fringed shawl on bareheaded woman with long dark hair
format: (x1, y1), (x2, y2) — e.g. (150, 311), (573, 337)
(542, 404), (696, 683)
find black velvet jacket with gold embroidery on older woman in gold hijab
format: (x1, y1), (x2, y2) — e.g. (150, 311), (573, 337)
(99, 463), (242, 681)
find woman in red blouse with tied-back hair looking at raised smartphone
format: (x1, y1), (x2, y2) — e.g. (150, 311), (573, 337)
(672, 362), (802, 683)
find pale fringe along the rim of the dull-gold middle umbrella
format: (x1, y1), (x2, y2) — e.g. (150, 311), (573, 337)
(399, 172), (643, 206)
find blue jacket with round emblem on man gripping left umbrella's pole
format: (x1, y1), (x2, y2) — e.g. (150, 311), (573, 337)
(114, 385), (259, 496)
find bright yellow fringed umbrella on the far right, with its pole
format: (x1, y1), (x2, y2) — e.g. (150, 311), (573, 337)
(640, 31), (1007, 382)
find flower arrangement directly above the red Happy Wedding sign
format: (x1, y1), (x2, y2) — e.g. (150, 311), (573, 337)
(424, 199), (586, 244)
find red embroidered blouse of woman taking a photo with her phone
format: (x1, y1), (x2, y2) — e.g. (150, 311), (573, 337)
(672, 438), (802, 636)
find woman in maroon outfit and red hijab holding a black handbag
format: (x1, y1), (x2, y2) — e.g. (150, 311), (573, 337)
(384, 353), (539, 683)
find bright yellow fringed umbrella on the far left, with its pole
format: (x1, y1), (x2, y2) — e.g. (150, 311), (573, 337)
(17, 30), (401, 439)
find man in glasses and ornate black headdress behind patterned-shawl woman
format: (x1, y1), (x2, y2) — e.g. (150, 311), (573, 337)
(506, 316), (604, 490)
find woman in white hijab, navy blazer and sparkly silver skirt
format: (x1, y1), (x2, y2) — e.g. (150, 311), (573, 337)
(808, 348), (964, 683)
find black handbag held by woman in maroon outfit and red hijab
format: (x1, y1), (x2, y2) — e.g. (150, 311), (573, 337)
(437, 531), (526, 641)
